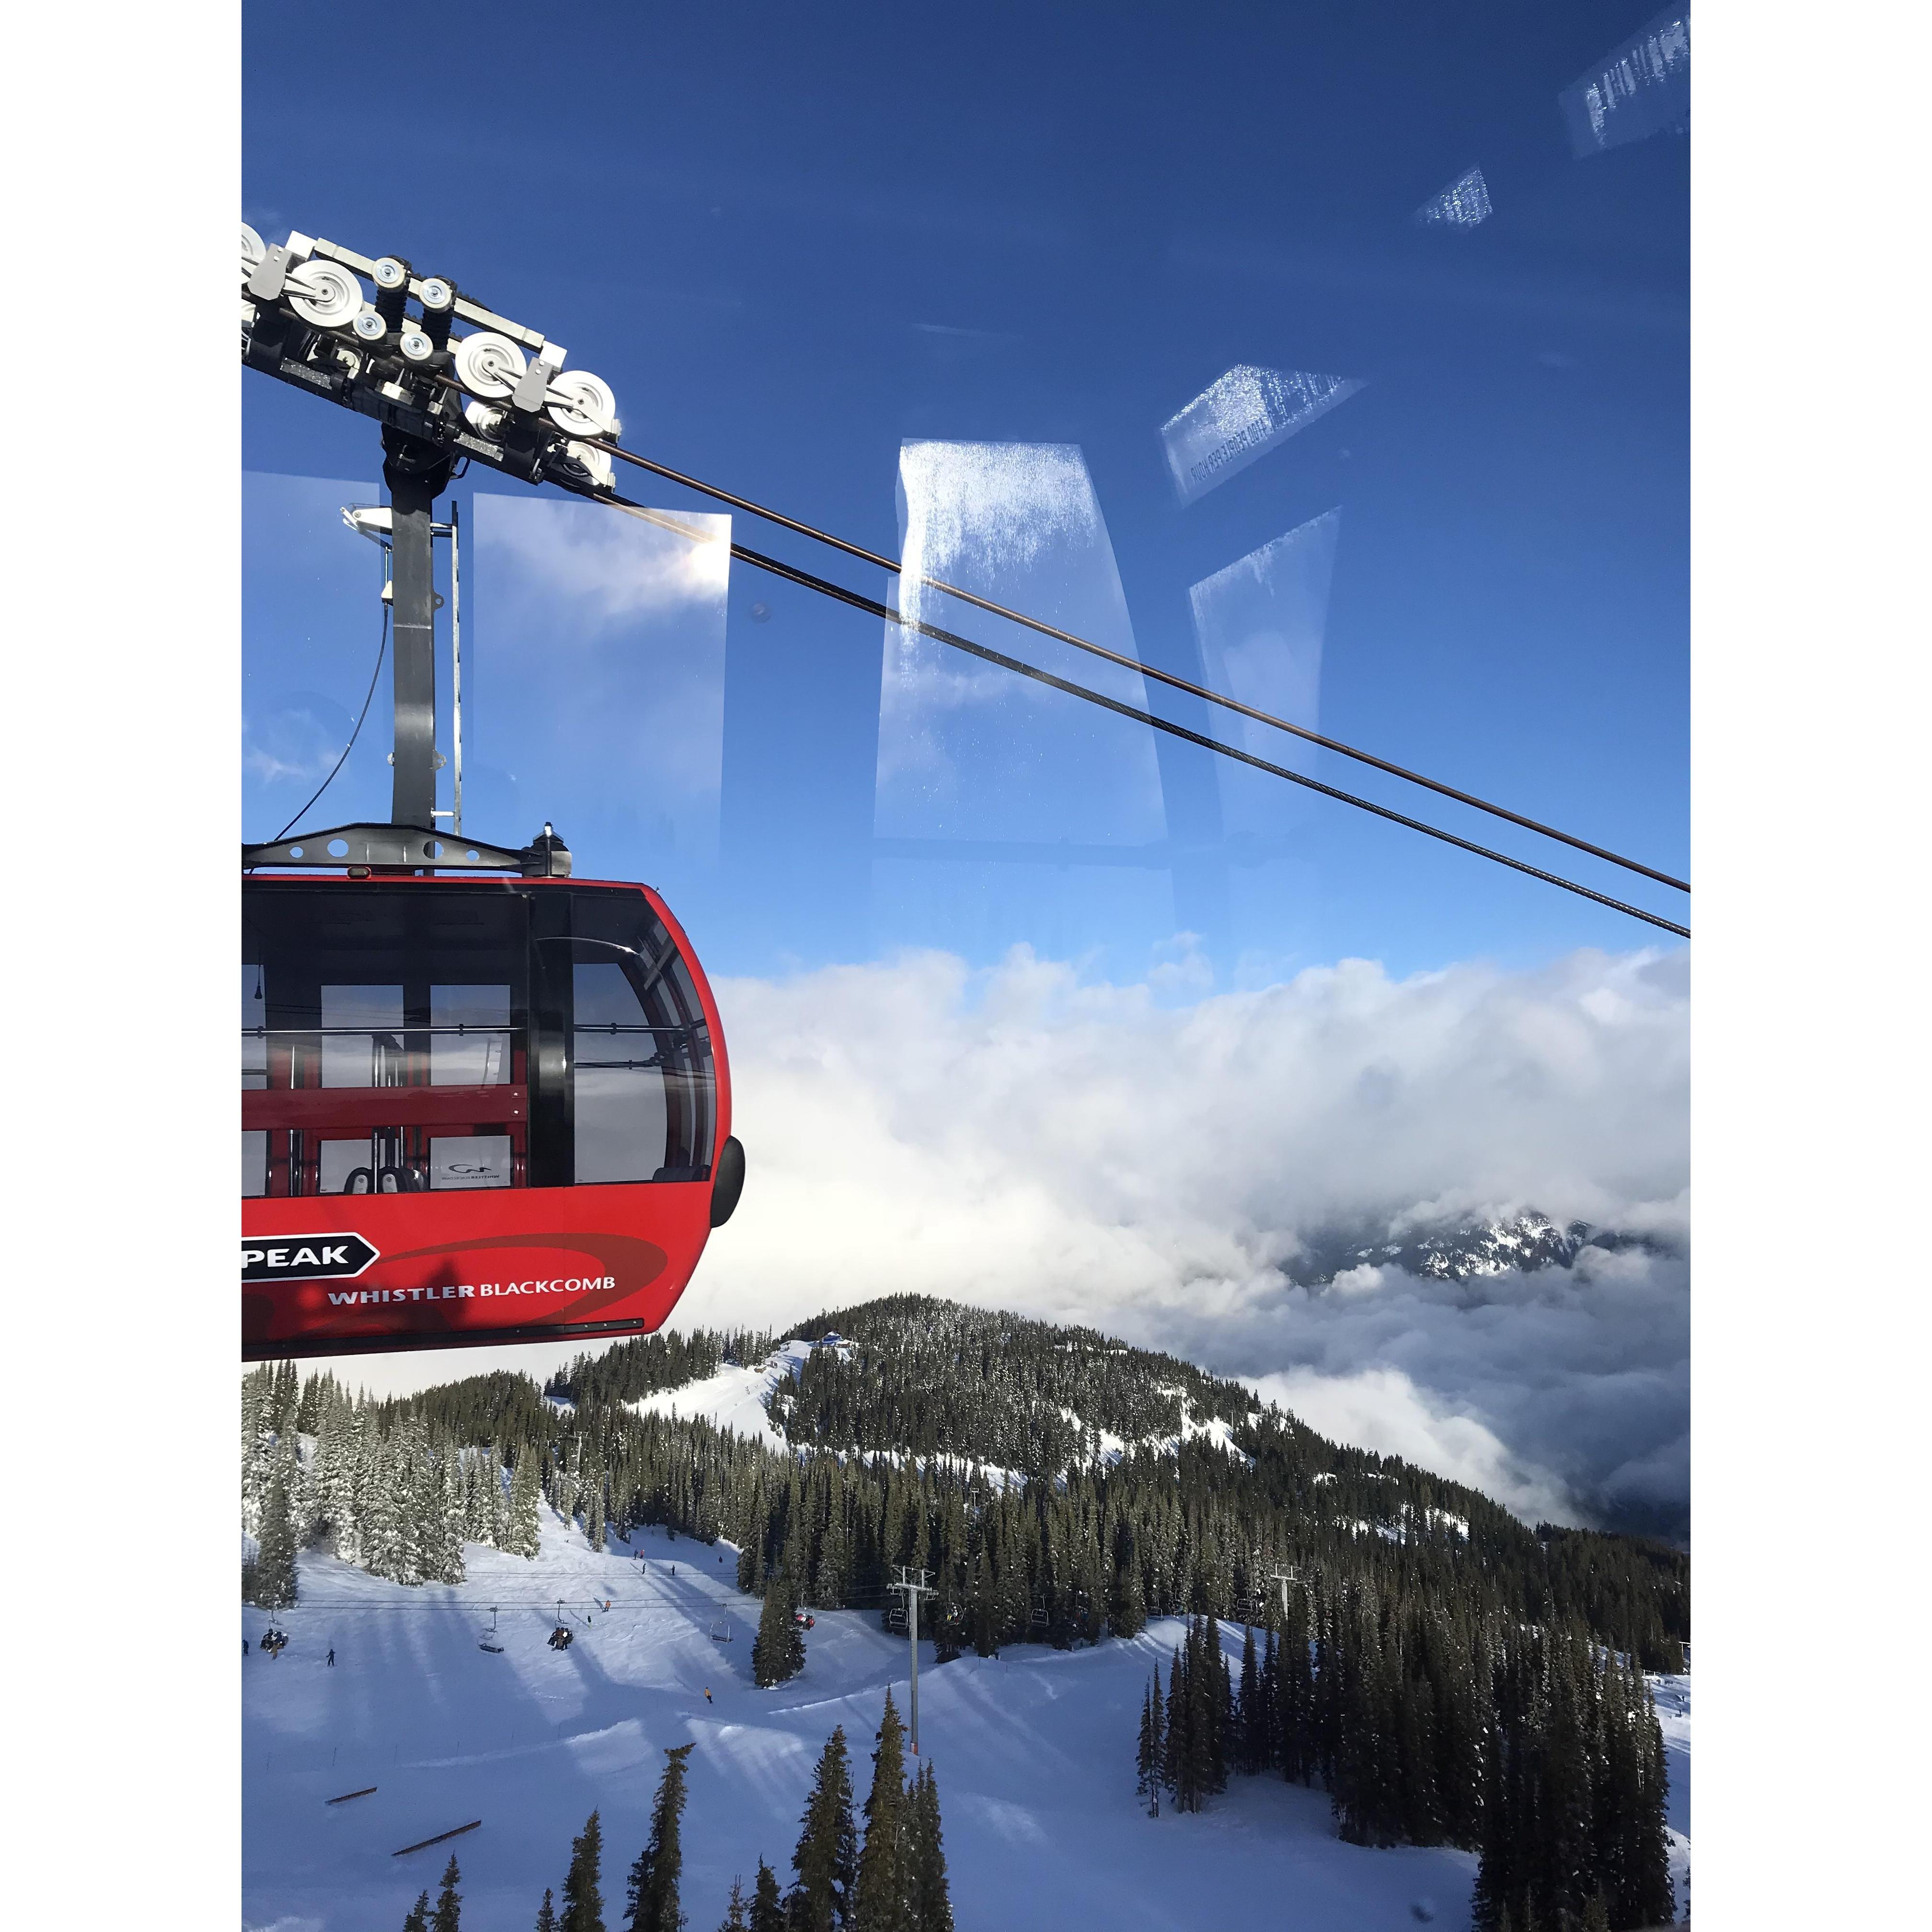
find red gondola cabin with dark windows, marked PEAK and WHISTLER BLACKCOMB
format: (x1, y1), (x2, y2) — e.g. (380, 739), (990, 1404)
(242, 873), (744, 1360)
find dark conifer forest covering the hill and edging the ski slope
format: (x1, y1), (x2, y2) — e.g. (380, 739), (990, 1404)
(242, 1296), (1690, 1932)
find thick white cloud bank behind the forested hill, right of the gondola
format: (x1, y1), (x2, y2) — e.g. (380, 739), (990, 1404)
(678, 951), (1689, 1522)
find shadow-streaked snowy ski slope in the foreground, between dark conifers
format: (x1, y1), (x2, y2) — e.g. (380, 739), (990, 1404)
(242, 1506), (1689, 1932)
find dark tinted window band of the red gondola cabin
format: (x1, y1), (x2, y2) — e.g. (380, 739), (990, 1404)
(242, 881), (717, 1196)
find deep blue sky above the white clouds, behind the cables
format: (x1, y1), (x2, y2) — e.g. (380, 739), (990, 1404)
(243, 4), (1689, 987)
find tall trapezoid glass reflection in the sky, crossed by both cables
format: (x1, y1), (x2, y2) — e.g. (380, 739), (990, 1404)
(873, 442), (1173, 962)
